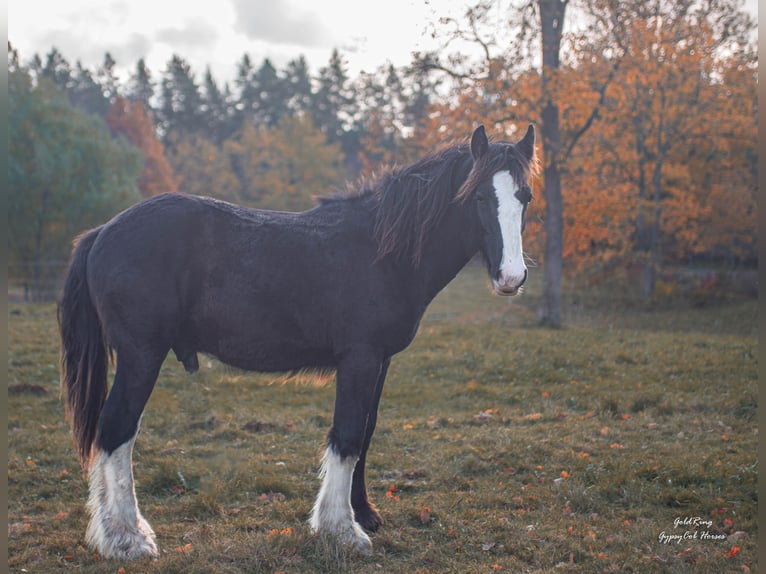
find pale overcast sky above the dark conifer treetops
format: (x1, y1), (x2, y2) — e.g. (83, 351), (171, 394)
(8, 0), (466, 83)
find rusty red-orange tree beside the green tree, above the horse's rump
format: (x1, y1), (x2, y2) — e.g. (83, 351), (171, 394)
(106, 96), (178, 197)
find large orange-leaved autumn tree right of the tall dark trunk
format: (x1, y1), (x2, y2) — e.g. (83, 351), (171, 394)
(589, 0), (757, 296)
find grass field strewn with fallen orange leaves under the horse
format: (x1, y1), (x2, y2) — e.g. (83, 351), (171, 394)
(8, 267), (758, 574)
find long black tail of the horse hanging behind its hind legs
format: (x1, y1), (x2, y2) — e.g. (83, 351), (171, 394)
(58, 227), (109, 472)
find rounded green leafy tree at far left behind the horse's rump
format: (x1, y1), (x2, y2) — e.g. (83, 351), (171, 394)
(8, 69), (141, 299)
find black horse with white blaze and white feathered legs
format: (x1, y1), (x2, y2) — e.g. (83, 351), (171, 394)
(57, 124), (536, 559)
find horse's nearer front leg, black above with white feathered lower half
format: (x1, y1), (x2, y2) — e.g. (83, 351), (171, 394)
(310, 347), (384, 554)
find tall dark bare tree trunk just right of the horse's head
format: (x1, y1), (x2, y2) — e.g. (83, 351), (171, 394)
(537, 0), (567, 327)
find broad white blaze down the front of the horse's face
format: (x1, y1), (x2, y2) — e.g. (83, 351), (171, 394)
(492, 171), (527, 289)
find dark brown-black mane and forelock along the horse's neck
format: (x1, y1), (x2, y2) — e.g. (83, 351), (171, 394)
(319, 138), (533, 266)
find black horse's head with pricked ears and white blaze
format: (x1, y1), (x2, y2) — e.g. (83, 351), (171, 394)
(459, 125), (535, 295)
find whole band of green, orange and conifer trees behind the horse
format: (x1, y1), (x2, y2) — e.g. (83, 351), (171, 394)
(8, 0), (758, 302)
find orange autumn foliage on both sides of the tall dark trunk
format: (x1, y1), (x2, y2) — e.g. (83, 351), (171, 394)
(400, 0), (757, 278)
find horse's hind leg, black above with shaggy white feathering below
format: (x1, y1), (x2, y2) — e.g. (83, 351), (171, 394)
(85, 351), (163, 559)
